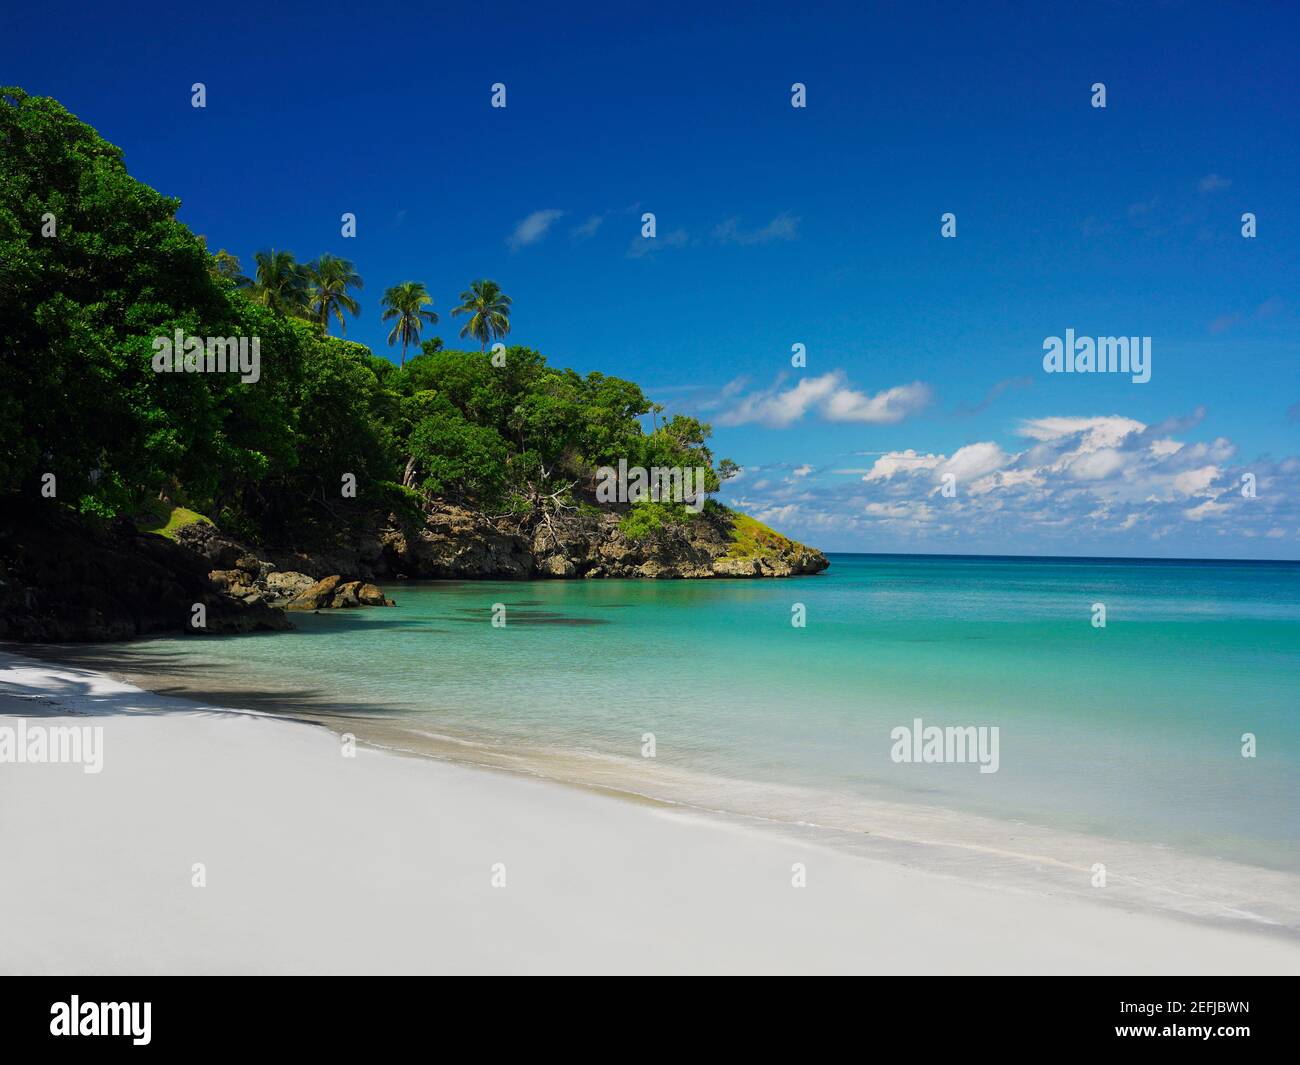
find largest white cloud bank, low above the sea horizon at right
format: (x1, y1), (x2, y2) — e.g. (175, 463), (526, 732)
(748, 410), (1284, 554)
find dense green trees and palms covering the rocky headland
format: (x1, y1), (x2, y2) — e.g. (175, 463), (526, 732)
(0, 90), (733, 540)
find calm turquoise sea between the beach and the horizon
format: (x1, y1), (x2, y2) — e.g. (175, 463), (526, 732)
(78, 554), (1300, 901)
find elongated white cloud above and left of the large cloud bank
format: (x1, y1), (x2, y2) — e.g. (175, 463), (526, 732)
(718, 371), (931, 429)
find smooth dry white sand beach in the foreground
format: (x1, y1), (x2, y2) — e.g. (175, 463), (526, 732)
(0, 654), (1300, 974)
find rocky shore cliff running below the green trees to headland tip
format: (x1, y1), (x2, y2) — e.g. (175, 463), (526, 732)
(0, 503), (829, 642)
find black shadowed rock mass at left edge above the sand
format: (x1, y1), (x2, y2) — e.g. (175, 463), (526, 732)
(0, 502), (293, 642)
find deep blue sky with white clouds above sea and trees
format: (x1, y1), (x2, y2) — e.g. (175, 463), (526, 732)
(0, 3), (1300, 558)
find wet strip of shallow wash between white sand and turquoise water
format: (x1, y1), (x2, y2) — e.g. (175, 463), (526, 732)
(10, 636), (1300, 943)
